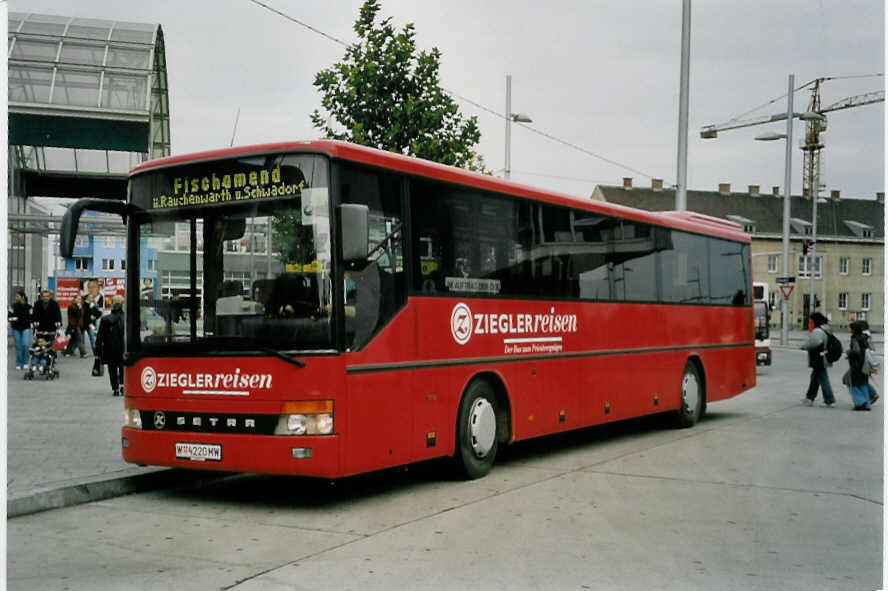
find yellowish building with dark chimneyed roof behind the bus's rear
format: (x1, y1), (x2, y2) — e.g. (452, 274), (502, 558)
(592, 178), (885, 332)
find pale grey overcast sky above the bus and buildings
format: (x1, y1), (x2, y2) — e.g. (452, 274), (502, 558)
(9, 0), (885, 199)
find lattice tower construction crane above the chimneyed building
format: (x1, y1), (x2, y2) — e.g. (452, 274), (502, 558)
(700, 77), (885, 196)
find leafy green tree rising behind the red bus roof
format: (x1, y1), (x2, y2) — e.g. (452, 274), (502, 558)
(311, 0), (487, 172)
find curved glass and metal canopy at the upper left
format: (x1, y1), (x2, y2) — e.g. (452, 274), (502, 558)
(8, 12), (170, 178)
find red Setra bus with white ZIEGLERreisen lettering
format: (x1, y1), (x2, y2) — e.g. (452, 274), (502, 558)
(62, 141), (756, 478)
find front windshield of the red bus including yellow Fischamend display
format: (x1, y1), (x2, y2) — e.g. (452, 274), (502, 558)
(129, 154), (333, 351)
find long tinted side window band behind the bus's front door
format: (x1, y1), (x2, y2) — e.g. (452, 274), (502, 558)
(411, 181), (749, 304)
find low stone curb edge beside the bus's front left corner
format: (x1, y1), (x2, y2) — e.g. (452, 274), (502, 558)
(6, 468), (228, 519)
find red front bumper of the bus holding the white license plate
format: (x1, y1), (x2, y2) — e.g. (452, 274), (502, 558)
(121, 427), (342, 478)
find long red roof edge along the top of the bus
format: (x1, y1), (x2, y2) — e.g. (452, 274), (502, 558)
(130, 140), (750, 243)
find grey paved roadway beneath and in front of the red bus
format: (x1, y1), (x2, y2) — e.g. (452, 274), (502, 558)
(7, 350), (884, 591)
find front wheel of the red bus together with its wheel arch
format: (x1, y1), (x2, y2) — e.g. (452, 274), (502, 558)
(454, 374), (511, 479)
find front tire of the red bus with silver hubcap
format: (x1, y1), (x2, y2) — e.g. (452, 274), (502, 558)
(454, 380), (499, 479)
